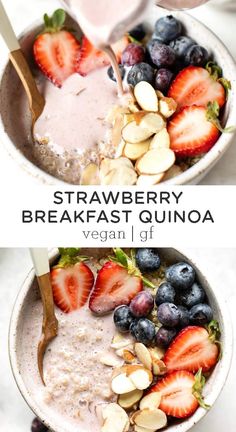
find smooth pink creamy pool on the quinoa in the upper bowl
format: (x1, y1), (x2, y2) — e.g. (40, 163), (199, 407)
(34, 68), (118, 154)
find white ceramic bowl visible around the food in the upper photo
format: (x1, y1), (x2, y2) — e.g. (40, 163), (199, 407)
(0, 7), (236, 184)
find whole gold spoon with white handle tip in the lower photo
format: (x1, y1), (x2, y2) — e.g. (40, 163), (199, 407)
(30, 248), (58, 385)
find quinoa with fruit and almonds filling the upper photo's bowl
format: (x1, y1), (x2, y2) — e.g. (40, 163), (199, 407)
(1, 9), (231, 186)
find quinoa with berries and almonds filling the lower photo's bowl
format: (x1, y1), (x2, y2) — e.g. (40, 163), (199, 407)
(21, 248), (220, 432)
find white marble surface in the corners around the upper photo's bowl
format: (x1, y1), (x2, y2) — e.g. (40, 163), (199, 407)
(0, 0), (236, 184)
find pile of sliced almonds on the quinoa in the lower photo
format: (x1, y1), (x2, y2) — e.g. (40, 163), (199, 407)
(97, 334), (167, 432)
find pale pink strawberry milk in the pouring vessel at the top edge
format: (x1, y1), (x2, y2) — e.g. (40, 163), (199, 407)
(64, 0), (151, 47)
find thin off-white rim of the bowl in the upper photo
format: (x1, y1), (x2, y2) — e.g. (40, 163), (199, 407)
(0, 6), (236, 185)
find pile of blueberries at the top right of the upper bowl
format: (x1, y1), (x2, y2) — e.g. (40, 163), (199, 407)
(108, 15), (210, 93)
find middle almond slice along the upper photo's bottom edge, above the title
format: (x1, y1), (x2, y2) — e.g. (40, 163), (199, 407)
(101, 167), (137, 186)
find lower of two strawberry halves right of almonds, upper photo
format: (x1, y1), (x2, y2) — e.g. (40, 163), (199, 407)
(168, 105), (220, 157)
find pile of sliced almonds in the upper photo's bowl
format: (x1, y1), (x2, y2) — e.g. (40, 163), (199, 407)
(81, 81), (182, 186)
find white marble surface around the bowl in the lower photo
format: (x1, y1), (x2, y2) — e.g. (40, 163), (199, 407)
(0, 249), (236, 432)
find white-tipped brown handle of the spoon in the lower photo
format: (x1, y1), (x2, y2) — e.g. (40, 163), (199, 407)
(30, 248), (55, 328)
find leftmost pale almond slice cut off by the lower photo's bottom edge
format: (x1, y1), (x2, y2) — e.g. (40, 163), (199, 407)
(101, 403), (129, 432)
